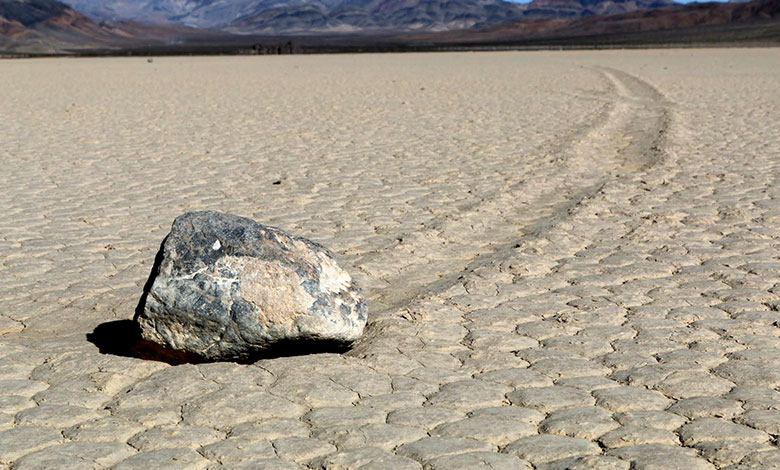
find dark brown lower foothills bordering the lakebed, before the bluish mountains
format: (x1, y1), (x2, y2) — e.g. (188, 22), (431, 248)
(0, 0), (780, 55)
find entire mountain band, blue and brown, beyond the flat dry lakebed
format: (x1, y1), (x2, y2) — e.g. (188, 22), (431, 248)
(0, 0), (780, 55)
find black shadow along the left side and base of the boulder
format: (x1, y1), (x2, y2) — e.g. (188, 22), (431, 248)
(87, 240), (351, 365)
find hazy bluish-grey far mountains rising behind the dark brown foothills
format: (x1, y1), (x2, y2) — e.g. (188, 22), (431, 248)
(59, 0), (672, 34)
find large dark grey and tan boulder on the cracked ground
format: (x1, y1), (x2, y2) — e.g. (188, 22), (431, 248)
(135, 211), (366, 361)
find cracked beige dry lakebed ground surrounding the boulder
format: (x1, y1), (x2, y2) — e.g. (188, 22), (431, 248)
(0, 49), (780, 470)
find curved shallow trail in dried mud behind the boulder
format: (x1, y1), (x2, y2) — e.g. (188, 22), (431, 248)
(355, 67), (669, 316)
